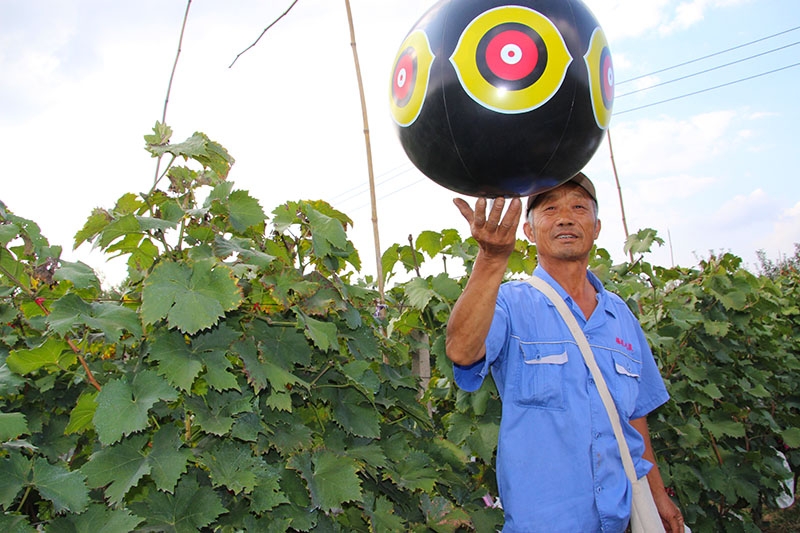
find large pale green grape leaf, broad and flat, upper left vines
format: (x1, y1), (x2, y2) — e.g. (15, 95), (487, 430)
(141, 260), (242, 334)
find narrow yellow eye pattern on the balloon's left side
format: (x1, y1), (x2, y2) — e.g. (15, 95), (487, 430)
(389, 30), (435, 127)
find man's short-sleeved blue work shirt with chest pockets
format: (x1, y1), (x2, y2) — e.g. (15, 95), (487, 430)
(454, 267), (669, 533)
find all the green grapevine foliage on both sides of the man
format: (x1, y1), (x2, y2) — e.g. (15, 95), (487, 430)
(0, 123), (800, 532)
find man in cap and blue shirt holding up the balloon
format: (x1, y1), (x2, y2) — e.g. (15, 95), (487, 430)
(447, 173), (684, 533)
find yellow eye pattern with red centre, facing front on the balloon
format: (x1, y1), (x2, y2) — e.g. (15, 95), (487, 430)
(450, 6), (572, 114)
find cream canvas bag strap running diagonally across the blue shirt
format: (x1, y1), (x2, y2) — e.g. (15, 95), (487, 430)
(527, 276), (637, 483)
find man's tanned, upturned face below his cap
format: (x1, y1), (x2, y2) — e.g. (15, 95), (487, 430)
(524, 183), (600, 261)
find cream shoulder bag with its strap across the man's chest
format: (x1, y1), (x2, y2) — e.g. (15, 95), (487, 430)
(528, 276), (665, 533)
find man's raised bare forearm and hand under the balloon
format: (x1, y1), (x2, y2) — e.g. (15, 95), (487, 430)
(446, 198), (522, 366)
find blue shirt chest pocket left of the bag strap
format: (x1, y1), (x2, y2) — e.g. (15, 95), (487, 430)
(516, 343), (569, 410)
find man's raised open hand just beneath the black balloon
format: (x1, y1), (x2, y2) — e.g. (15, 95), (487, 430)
(453, 197), (522, 260)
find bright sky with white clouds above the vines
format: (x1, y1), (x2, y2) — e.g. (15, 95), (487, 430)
(0, 0), (800, 284)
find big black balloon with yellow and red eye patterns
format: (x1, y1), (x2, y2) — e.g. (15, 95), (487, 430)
(390, 0), (614, 197)
